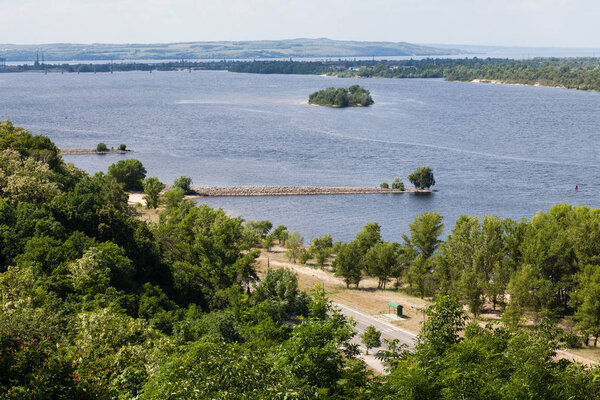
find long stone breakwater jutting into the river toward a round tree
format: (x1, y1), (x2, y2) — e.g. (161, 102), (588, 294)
(191, 185), (433, 197)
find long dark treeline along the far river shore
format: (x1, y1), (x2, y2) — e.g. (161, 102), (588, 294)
(0, 58), (600, 90)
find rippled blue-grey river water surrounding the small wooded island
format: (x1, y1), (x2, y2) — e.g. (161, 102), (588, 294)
(0, 71), (600, 241)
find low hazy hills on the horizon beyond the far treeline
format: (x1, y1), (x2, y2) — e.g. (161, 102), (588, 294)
(0, 38), (459, 61)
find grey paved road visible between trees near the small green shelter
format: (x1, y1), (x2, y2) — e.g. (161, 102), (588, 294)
(334, 303), (416, 373)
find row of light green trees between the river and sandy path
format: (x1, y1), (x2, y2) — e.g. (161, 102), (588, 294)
(332, 204), (600, 345)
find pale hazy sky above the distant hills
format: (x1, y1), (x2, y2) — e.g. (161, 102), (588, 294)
(0, 0), (600, 48)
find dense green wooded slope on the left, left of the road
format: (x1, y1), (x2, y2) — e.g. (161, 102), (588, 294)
(0, 123), (376, 399)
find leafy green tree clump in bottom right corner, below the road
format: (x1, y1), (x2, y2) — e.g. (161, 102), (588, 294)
(374, 296), (600, 400)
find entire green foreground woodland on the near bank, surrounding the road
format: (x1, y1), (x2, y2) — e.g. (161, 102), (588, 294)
(0, 121), (600, 399)
